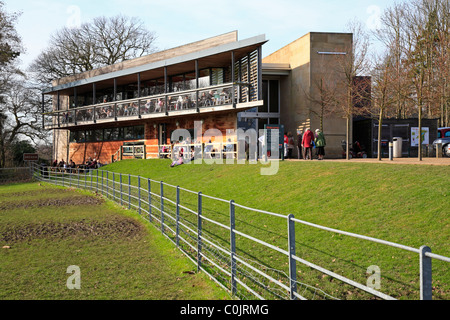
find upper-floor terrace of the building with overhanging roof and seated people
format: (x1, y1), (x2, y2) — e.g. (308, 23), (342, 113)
(42, 32), (266, 129)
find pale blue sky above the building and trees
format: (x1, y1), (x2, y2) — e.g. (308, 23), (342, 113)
(4, 0), (394, 69)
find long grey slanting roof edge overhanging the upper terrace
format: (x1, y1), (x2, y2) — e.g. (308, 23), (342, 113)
(42, 35), (267, 94)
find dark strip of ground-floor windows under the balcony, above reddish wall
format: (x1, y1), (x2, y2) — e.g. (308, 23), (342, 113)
(70, 126), (145, 143)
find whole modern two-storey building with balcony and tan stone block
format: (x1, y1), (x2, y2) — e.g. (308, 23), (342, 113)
(43, 31), (352, 164)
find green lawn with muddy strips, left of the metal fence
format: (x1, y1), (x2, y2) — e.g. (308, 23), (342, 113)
(0, 183), (229, 300)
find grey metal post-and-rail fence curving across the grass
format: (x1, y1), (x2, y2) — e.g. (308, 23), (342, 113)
(29, 165), (450, 300)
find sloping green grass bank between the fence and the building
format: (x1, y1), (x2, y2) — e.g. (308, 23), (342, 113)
(96, 160), (450, 299)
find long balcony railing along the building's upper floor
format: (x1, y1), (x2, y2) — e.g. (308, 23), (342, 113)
(44, 83), (250, 129)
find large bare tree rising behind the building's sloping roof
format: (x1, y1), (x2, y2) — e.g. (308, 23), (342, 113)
(30, 15), (156, 84)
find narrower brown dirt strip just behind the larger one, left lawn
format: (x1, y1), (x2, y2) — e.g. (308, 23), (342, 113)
(0, 195), (103, 211)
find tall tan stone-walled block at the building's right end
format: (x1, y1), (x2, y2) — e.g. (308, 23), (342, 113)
(263, 32), (352, 158)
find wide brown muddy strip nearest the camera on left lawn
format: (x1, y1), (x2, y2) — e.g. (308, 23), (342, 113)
(0, 217), (145, 244)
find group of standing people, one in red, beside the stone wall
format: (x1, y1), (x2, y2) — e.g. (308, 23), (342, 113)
(284, 128), (326, 160)
